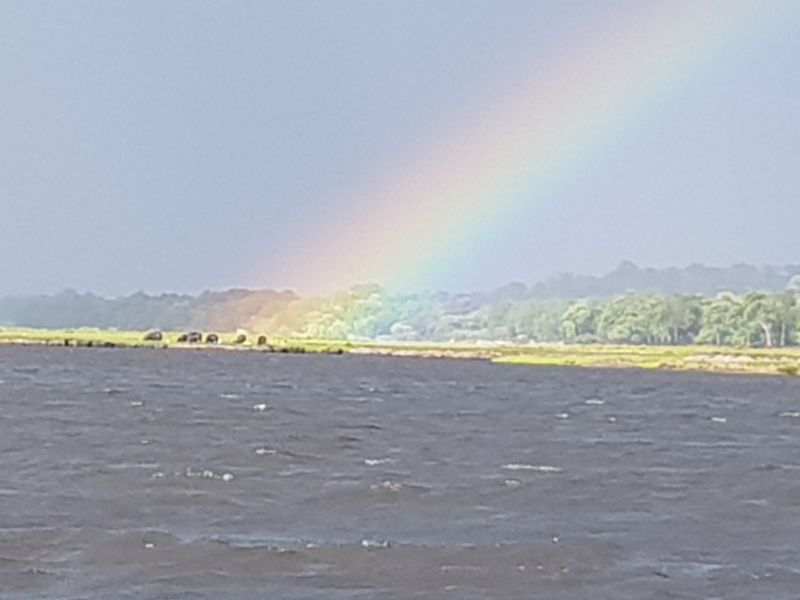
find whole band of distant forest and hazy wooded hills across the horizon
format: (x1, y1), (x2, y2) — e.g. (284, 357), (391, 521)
(0, 262), (800, 346)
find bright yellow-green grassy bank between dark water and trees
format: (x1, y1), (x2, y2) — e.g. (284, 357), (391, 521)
(0, 328), (800, 375)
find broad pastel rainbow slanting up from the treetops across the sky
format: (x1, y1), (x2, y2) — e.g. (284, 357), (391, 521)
(262, 0), (788, 292)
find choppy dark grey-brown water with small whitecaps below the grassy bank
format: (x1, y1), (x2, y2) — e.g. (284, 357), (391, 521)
(0, 347), (800, 600)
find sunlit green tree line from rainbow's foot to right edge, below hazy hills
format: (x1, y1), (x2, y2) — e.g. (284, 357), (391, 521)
(296, 288), (800, 347)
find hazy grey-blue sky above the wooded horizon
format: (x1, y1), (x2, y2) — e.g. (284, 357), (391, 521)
(0, 0), (800, 296)
